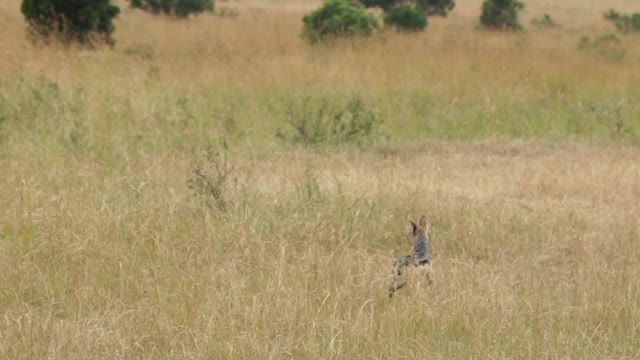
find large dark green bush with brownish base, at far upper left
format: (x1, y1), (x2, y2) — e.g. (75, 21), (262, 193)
(21, 0), (120, 45)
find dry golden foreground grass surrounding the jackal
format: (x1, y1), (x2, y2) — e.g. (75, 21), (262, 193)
(0, 145), (640, 358)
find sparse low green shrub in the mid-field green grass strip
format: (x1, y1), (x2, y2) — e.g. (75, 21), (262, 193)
(276, 97), (381, 145)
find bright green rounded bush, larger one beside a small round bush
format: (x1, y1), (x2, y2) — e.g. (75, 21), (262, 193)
(302, 0), (379, 43)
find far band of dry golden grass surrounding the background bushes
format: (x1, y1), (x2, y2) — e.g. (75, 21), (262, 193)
(0, 0), (640, 91)
